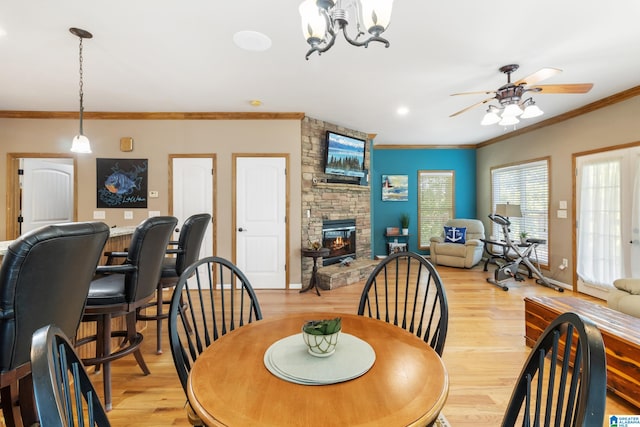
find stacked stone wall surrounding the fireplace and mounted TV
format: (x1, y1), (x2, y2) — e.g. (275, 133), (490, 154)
(301, 117), (371, 287)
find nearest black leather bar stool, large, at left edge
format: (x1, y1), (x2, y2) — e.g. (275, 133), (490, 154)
(0, 222), (109, 426)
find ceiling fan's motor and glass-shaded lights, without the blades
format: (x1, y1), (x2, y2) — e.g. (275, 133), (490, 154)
(480, 65), (544, 126)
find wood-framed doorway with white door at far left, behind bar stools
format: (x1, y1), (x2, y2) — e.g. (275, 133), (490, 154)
(5, 153), (78, 240)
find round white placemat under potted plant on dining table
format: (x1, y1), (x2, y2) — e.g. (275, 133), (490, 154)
(264, 333), (376, 385)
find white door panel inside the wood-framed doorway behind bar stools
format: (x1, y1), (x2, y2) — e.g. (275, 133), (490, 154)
(21, 158), (74, 234)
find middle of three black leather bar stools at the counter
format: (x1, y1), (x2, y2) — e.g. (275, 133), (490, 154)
(76, 216), (178, 411)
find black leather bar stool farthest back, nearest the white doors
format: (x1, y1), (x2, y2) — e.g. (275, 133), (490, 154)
(138, 213), (211, 354)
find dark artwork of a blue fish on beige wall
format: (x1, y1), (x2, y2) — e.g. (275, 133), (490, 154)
(96, 159), (149, 208)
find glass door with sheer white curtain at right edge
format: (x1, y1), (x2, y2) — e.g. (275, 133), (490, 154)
(576, 147), (640, 299)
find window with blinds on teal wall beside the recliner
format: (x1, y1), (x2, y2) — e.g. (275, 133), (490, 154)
(418, 171), (454, 249)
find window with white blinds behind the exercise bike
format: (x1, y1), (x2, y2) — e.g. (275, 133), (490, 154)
(491, 158), (549, 266)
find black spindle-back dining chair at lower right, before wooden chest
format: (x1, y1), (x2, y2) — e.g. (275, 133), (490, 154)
(502, 312), (607, 427)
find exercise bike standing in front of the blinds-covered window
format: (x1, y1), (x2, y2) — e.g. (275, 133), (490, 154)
(487, 214), (564, 292)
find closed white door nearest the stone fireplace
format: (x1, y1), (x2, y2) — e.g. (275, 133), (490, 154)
(235, 157), (286, 289)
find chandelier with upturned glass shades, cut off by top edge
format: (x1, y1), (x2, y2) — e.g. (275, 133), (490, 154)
(299, 0), (393, 60)
